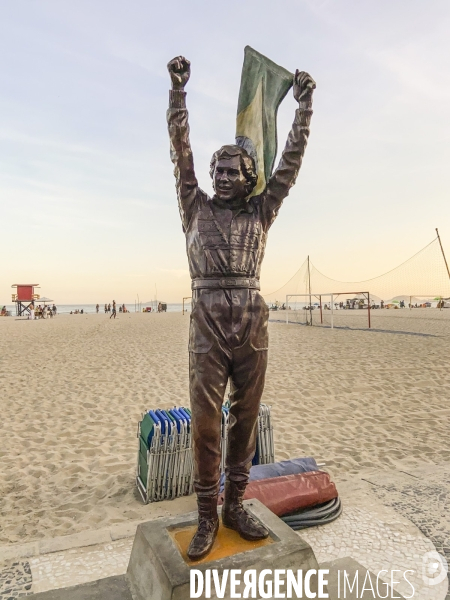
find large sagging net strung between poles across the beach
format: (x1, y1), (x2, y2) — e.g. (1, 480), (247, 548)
(264, 236), (450, 331)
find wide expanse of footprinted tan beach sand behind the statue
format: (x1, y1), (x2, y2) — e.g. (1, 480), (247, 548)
(0, 309), (450, 544)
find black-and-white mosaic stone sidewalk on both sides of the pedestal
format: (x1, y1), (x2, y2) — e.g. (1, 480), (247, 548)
(0, 465), (450, 600)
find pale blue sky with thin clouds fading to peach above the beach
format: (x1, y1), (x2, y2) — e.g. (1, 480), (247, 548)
(0, 0), (450, 304)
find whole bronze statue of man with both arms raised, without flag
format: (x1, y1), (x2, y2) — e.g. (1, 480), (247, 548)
(167, 56), (315, 560)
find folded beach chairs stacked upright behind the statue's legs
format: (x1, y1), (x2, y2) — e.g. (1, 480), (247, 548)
(136, 403), (275, 504)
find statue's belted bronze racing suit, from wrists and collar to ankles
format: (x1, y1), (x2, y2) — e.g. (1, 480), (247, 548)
(167, 90), (312, 496)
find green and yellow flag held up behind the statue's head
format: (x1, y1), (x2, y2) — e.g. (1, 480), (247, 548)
(236, 46), (294, 196)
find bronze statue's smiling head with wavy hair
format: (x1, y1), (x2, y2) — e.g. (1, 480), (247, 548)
(209, 144), (258, 202)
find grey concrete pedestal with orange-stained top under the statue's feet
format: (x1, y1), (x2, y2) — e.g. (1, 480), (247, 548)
(127, 500), (319, 600)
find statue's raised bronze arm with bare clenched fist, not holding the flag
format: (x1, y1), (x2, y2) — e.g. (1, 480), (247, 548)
(167, 56), (198, 230)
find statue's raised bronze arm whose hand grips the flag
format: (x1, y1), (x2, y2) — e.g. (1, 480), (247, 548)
(261, 70), (316, 231)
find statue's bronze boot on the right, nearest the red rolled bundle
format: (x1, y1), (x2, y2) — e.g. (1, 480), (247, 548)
(222, 481), (269, 541)
